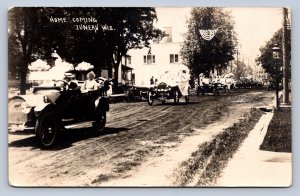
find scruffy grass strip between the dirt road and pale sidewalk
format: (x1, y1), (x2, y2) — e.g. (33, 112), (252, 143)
(174, 108), (263, 186)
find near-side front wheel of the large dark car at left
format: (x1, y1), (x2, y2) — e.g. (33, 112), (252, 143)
(35, 112), (59, 148)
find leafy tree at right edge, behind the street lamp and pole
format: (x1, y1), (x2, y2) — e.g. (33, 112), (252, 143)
(256, 29), (291, 79)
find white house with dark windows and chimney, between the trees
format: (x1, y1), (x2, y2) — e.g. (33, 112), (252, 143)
(125, 27), (183, 86)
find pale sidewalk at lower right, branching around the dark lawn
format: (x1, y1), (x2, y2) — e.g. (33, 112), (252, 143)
(217, 105), (292, 187)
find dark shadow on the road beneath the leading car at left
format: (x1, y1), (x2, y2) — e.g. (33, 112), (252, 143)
(8, 127), (130, 150)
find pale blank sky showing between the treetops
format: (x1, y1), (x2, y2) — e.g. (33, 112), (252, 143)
(156, 7), (282, 66)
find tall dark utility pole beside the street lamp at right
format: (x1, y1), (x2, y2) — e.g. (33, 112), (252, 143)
(282, 8), (289, 104)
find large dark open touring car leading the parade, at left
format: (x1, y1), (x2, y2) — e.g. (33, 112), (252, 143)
(8, 77), (109, 148)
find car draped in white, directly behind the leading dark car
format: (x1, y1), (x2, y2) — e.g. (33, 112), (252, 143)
(147, 70), (190, 106)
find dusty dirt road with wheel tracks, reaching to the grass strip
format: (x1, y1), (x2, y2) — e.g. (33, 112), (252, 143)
(8, 89), (273, 187)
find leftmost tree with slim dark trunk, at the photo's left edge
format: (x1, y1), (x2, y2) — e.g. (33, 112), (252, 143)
(8, 7), (43, 94)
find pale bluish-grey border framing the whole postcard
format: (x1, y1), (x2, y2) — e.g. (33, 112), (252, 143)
(0, 0), (300, 196)
